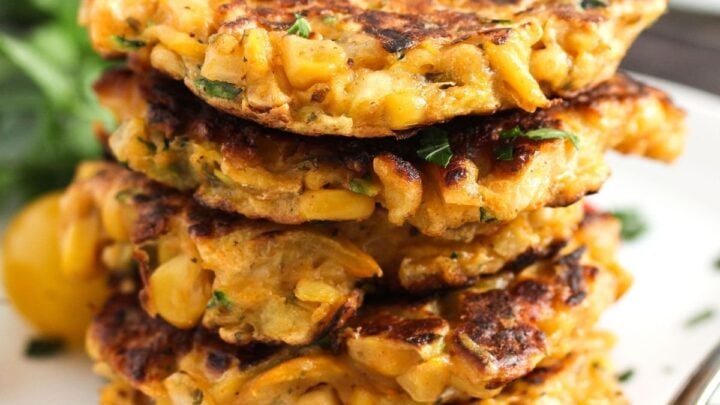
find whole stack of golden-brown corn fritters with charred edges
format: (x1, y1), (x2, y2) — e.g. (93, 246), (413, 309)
(54, 0), (683, 405)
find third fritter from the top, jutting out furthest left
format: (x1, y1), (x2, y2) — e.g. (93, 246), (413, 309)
(61, 162), (583, 345)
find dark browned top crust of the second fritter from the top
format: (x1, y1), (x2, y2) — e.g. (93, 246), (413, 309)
(95, 70), (677, 185)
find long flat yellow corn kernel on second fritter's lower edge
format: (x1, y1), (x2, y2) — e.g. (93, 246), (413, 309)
(300, 190), (375, 221)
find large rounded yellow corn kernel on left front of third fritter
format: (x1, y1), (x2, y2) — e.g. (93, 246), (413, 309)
(148, 254), (211, 329)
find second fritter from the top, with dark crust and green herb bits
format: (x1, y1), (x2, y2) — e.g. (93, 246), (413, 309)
(96, 71), (684, 240)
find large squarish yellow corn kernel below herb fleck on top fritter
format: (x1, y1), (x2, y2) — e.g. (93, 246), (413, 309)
(281, 35), (347, 90)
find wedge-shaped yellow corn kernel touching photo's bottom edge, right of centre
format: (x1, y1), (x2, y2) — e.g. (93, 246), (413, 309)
(397, 357), (450, 402)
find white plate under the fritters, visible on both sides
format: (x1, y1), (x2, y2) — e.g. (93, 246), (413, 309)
(0, 78), (720, 405)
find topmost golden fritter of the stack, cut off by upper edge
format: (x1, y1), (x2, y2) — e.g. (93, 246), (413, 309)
(80, 0), (667, 137)
